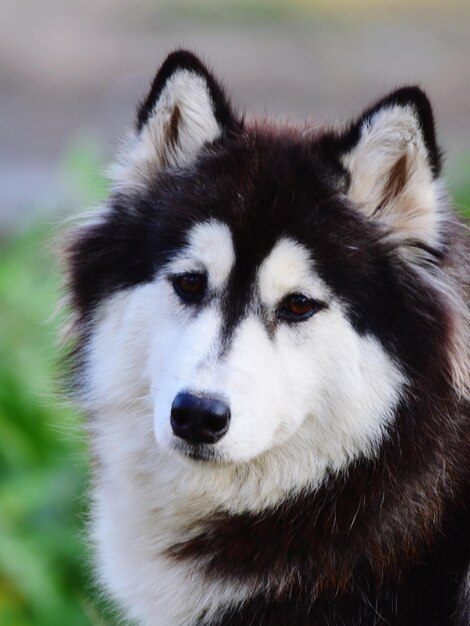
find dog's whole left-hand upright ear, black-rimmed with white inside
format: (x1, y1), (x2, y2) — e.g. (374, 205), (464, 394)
(110, 50), (242, 188)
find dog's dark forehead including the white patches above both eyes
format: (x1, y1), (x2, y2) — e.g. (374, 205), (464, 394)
(155, 127), (375, 320)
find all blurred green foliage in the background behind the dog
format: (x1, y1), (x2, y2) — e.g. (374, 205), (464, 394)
(0, 141), (470, 626)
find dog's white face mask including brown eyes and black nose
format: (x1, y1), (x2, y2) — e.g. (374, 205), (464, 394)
(149, 219), (401, 462)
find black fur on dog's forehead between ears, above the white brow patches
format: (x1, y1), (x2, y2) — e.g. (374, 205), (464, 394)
(152, 129), (354, 252)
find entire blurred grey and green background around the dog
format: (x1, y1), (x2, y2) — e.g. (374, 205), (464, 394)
(0, 0), (470, 626)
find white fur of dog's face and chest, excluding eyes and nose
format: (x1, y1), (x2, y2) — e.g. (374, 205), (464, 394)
(83, 221), (405, 626)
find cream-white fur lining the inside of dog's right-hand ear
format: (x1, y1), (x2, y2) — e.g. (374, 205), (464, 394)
(343, 105), (443, 261)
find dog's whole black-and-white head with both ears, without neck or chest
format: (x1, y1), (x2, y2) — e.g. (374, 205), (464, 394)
(67, 53), (456, 478)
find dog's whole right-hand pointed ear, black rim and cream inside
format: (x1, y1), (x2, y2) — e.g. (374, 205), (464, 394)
(337, 87), (443, 261)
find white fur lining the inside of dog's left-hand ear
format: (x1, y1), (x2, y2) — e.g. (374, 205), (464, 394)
(109, 70), (221, 189)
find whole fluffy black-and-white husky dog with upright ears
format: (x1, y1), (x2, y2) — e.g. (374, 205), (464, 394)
(67, 51), (470, 626)
